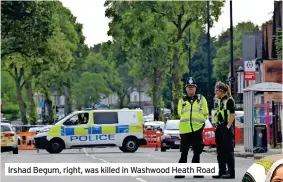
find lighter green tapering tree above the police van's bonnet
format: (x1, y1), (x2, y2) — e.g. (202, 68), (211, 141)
(36, 2), (88, 122)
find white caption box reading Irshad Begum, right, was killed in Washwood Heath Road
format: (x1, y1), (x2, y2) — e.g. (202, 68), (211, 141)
(5, 163), (218, 176)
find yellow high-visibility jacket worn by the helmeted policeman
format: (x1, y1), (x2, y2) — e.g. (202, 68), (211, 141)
(179, 95), (207, 134)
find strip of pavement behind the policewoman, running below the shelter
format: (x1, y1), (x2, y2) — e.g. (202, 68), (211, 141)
(205, 144), (283, 159)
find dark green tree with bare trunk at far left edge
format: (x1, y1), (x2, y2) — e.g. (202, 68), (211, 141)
(1, 1), (55, 124)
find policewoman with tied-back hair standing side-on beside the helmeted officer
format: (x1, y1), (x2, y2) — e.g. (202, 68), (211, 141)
(213, 82), (235, 179)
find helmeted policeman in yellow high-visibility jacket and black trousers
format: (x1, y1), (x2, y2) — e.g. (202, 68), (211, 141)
(175, 77), (208, 178)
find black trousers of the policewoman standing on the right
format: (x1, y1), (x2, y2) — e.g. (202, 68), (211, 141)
(215, 124), (235, 176)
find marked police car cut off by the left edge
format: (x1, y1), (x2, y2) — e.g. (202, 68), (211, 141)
(0, 123), (19, 154)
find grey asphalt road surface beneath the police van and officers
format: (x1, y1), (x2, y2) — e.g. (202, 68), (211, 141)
(1, 148), (255, 182)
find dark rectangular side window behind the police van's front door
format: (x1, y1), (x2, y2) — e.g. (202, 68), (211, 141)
(93, 112), (118, 124)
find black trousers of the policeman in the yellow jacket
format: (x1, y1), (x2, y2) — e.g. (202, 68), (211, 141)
(179, 128), (204, 163)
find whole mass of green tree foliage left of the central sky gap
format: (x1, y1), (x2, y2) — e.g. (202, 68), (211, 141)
(1, 1), (89, 123)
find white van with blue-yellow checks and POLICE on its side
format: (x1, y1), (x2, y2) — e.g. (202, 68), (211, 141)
(34, 110), (146, 153)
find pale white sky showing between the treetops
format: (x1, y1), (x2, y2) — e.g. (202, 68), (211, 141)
(60, 0), (274, 46)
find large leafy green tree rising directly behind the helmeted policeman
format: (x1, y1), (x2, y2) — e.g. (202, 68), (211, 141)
(105, 1), (224, 118)
